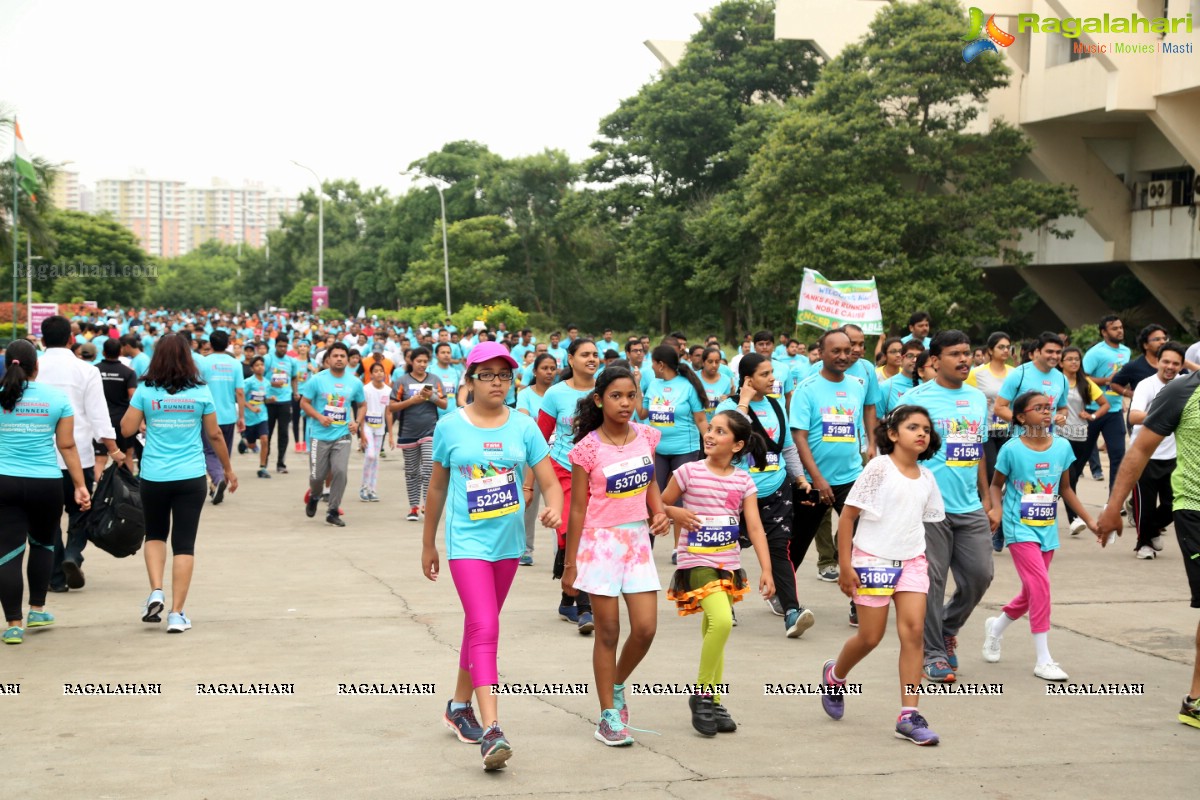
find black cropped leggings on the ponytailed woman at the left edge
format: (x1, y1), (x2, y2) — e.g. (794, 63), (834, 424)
(0, 475), (62, 622)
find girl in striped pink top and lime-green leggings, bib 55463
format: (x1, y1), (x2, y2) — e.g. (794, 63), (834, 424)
(662, 411), (775, 736)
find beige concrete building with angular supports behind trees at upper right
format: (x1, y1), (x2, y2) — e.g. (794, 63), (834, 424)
(775, 0), (1200, 327)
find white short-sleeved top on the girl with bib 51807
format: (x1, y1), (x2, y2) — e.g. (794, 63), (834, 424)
(846, 456), (946, 561)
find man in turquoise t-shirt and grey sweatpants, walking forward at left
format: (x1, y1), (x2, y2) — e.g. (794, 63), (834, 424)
(300, 342), (367, 528)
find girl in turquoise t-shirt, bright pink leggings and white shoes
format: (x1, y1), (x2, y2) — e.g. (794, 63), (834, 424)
(983, 391), (1099, 680)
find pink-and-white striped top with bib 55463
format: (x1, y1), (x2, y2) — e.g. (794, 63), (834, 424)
(674, 461), (758, 572)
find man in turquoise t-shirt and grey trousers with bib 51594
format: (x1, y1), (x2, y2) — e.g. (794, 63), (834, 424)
(904, 330), (1001, 684)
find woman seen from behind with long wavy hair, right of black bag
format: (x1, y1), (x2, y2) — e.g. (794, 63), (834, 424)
(121, 335), (238, 633)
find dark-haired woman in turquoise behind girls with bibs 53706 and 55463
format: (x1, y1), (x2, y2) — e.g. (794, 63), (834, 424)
(638, 344), (708, 491)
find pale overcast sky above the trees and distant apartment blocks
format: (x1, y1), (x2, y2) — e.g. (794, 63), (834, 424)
(0, 0), (712, 192)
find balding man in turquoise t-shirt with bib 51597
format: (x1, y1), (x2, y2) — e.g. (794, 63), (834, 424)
(787, 327), (866, 582)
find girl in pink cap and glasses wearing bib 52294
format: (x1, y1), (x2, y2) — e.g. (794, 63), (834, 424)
(421, 342), (563, 770)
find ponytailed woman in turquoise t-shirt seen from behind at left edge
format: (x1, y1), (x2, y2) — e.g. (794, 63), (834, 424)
(0, 339), (91, 644)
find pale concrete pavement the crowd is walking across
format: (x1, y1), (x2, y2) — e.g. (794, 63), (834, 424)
(0, 453), (1200, 800)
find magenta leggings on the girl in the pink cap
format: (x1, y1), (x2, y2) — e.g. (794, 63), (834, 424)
(450, 559), (517, 686)
